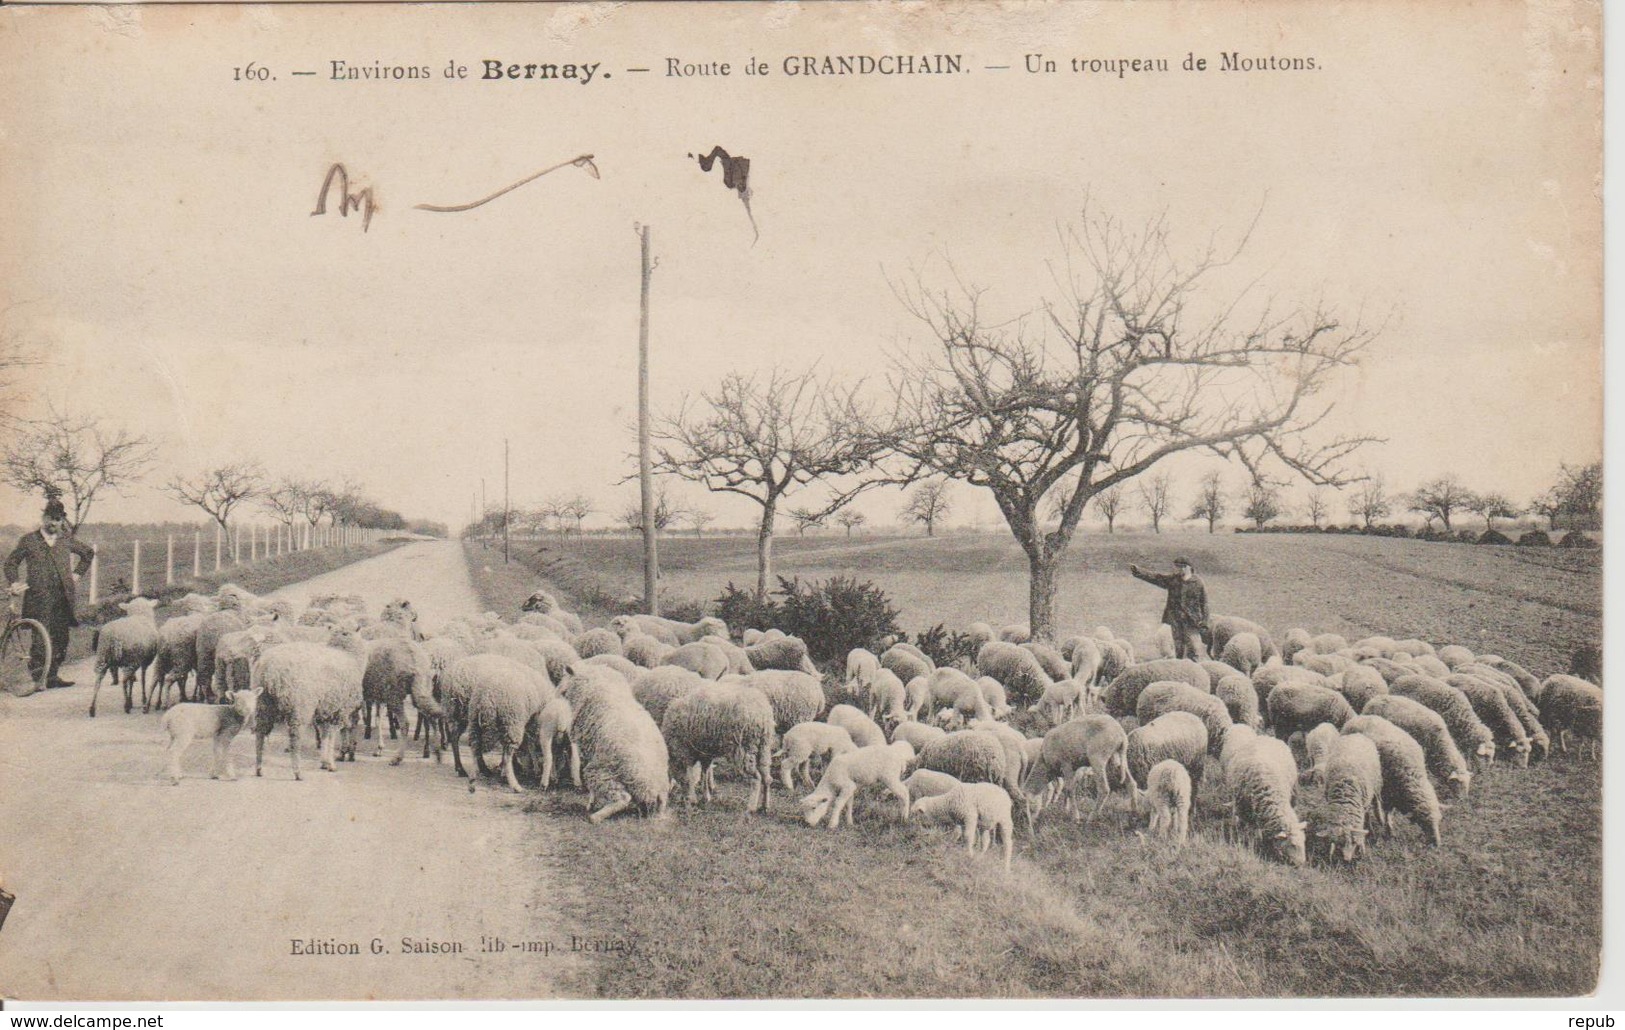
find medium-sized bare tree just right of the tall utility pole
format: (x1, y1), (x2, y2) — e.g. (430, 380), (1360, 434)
(655, 369), (884, 596)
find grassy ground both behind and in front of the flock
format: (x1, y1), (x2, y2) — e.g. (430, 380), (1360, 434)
(470, 534), (1602, 998)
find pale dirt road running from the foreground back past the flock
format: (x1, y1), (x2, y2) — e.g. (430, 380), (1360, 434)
(0, 541), (582, 999)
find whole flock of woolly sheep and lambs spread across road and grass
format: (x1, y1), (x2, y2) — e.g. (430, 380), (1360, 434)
(91, 585), (1602, 866)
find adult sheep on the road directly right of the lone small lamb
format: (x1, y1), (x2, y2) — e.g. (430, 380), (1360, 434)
(250, 629), (367, 780)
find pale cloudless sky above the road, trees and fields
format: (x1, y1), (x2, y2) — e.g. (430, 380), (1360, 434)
(0, 3), (1602, 526)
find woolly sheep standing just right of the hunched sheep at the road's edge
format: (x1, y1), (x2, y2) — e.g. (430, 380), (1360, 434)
(660, 682), (777, 814)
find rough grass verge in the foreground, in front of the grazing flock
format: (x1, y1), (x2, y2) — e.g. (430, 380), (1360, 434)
(466, 538), (1602, 998)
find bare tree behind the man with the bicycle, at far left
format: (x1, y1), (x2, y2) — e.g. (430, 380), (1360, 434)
(0, 411), (153, 533)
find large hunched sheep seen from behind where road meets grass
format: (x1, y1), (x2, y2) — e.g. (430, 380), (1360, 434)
(559, 666), (671, 824)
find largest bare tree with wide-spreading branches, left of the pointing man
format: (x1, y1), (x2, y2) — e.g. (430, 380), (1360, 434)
(892, 210), (1372, 637)
